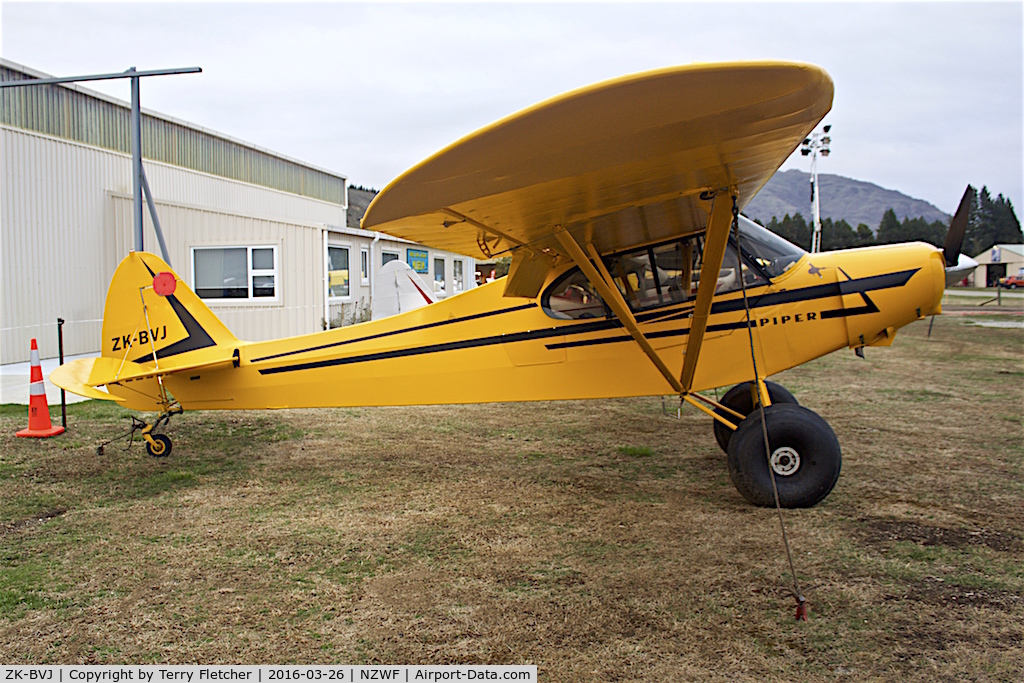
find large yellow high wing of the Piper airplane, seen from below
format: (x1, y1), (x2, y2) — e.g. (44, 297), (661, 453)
(362, 61), (833, 296)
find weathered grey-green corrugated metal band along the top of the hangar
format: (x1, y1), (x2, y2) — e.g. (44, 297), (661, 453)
(0, 58), (346, 206)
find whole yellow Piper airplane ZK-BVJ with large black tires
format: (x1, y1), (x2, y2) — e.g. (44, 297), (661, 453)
(50, 61), (967, 507)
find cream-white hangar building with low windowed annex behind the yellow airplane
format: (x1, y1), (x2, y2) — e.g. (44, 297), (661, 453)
(0, 59), (475, 365)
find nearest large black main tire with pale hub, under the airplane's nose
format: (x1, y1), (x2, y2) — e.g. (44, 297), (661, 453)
(729, 403), (843, 508)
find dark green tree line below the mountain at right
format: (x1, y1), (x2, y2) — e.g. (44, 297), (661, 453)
(759, 186), (1024, 256)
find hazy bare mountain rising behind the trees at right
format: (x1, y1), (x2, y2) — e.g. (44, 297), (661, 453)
(743, 169), (949, 231)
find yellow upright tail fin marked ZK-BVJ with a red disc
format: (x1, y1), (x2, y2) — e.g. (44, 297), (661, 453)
(101, 252), (239, 366)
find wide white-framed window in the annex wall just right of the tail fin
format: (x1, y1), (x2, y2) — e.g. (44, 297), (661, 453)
(193, 247), (278, 300)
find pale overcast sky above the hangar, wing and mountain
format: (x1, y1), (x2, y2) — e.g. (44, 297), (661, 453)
(0, 1), (1024, 216)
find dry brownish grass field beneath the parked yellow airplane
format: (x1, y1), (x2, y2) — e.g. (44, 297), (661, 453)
(0, 315), (1024, 682)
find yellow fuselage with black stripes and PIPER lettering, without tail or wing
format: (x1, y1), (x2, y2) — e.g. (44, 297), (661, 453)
(155, 244), (944, 410)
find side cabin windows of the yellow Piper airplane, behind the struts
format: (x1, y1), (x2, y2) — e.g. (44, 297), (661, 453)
(541, 228), (770, 319)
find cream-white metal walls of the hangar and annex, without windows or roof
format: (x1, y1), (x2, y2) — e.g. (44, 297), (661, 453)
(0, 126), (475, 365)
